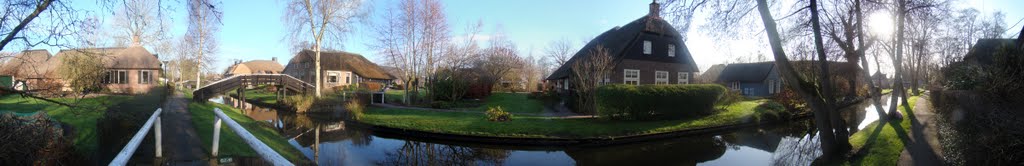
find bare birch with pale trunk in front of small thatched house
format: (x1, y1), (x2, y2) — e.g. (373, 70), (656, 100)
(284, 0), (367, 97)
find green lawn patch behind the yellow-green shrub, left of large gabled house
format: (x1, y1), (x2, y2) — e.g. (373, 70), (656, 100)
(472, 92), (544, 114)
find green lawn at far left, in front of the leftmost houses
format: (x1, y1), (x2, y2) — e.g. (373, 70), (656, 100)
(0, 95), (132, 154)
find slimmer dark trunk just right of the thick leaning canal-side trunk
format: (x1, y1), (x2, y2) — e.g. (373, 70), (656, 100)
(811, 0), (851, 152)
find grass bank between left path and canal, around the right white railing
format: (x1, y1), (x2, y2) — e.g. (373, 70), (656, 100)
(188, 102), (309, 162)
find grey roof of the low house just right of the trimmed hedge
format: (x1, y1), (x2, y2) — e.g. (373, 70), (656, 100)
(718, 61), (775, 82)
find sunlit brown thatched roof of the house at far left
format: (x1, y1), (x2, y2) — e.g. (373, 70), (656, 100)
(57, 46), (160, 70)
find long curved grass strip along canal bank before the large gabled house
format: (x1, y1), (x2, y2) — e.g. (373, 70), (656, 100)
(359, 99), (768, 138)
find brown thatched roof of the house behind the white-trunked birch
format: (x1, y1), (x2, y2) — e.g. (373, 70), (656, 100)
(285, 49), (394, 80)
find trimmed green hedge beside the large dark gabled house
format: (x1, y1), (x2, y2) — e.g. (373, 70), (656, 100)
(597, 84), (727, 120)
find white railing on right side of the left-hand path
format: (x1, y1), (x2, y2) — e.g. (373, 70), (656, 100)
(211, 109), (294, 165)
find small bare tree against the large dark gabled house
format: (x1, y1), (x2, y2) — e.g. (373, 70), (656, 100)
(569, 45), (615, 114)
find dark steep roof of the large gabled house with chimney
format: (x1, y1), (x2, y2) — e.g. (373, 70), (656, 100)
(547, 4), (699, 80)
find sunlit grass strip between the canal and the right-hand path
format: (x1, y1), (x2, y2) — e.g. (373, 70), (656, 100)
(843, 96), (920, 165)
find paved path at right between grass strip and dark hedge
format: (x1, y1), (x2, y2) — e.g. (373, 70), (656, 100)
(899, 94), (945, 166)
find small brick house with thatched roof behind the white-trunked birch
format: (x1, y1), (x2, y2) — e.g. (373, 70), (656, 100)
(284, 49), (394, 89)
